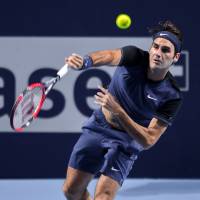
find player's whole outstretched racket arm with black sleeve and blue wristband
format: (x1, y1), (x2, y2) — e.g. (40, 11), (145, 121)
(65, 46), (148, 69)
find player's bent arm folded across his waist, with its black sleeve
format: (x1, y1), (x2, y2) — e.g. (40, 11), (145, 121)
(95, 87), (182, 149)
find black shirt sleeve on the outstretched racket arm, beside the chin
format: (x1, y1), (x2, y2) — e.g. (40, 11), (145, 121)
(119, 46), (148, 67)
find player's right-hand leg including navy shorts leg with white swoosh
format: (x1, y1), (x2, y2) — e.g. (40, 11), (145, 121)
(95, 140), (135, 200)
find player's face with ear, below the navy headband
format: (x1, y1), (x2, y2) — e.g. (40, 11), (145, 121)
(149, 38), (180, 70)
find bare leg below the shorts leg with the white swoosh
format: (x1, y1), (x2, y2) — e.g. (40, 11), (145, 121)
(95, 174), (120, 200)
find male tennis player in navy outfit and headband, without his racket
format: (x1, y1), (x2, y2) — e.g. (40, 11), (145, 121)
(63, 20), (182, 200)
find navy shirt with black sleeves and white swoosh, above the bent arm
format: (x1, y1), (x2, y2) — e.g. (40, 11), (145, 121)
(109, 46), (182, 127)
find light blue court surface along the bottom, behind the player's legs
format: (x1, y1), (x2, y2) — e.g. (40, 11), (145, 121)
(0, 179), (200, 200)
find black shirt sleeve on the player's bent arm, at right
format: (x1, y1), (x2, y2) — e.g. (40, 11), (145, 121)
(154, 99), (182, 126)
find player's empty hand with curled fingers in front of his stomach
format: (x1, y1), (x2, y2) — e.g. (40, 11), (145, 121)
(94, 86), (122, 115)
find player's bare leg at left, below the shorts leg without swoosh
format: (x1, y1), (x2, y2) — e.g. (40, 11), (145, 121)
(63, 167), (94, 200)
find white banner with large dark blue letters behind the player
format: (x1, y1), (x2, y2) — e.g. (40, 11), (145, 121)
(0, 37), (188, 133)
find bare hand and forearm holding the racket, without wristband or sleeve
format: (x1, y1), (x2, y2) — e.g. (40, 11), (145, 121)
(65, 49), (122, 69)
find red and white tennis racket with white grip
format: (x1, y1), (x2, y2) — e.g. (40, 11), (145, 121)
(10, 64), (69, 132)
